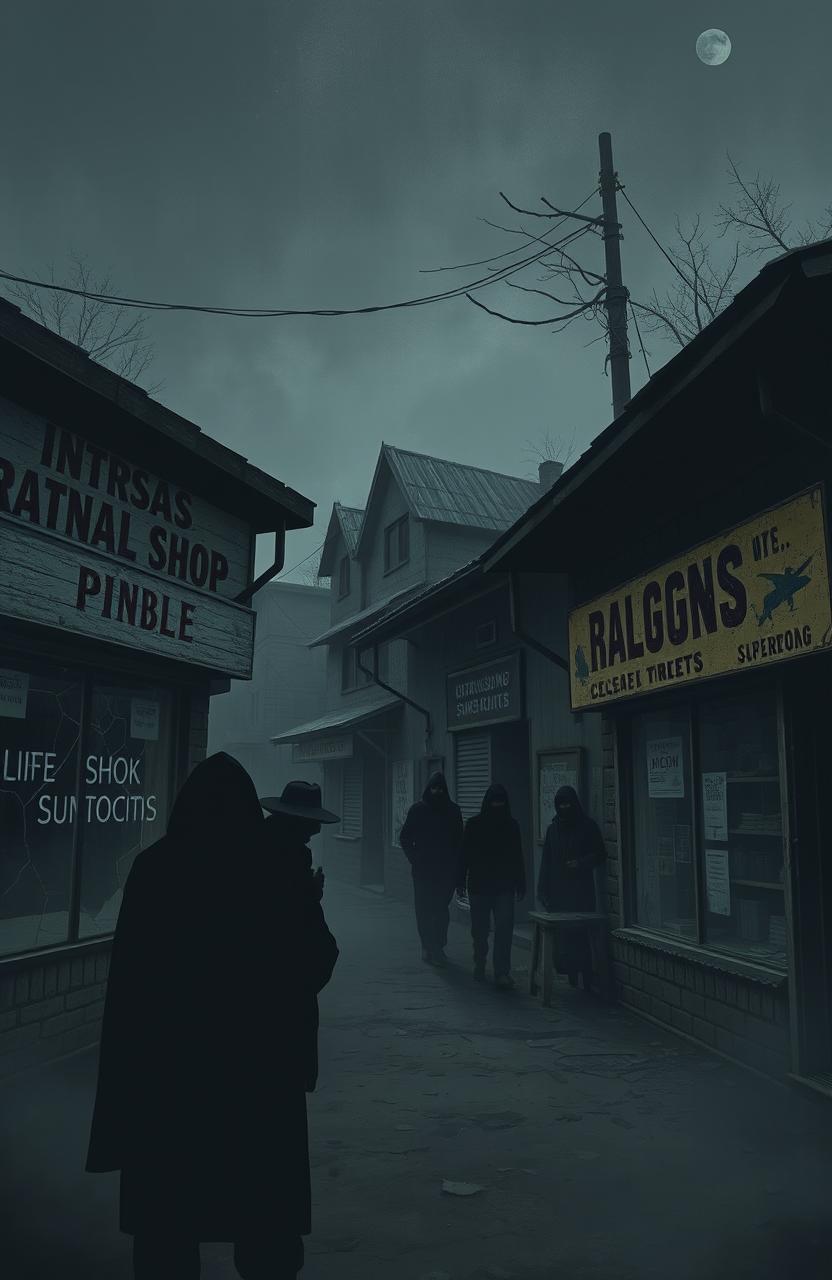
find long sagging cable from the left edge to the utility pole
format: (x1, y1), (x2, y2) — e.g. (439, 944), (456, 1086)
(0, 218), (599, 319)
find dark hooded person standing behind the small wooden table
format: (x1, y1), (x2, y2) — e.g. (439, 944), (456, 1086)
(538, 787), (607, 991)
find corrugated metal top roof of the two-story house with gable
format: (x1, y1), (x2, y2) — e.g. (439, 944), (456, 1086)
(383, 444), (543, 532)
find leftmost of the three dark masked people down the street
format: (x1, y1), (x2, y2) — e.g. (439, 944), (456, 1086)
(399, 772), (462, 966)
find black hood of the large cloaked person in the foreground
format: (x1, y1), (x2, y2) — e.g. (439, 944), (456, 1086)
(168, 751), (264, 849)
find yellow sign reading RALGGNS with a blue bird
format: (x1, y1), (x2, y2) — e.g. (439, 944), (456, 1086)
(570, 485), (832, 709)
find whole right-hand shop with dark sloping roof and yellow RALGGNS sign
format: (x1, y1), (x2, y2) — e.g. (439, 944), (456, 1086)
(478, 241), (832, 1092)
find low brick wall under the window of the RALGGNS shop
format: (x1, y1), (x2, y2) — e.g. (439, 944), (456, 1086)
(612, 938), (791, 1079)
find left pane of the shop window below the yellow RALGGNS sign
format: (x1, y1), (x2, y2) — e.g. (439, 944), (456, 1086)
(632, 709), (698, 942)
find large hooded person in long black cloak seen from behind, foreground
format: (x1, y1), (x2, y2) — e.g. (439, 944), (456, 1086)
(86, 753), (338, 1280)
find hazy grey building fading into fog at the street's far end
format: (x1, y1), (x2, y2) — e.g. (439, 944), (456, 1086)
(209, 582), (329, 795)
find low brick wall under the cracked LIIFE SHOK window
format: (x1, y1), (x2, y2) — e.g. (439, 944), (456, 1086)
(0, 950), (110, 1078)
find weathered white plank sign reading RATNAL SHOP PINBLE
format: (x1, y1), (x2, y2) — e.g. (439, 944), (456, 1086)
(0, 399), (253, 678)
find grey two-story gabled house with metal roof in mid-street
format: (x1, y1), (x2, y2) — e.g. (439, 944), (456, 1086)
(273, 444), (541, 890)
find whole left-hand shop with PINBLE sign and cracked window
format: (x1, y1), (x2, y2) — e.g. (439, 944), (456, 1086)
(0, 308), (311, 1073)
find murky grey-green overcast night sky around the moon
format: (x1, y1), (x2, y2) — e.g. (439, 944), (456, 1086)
(0, 0), (832, 581)
